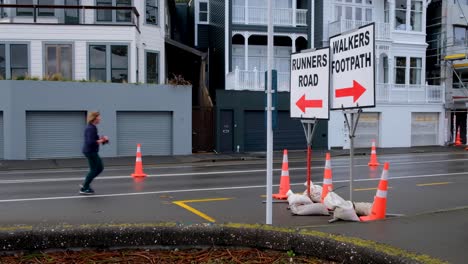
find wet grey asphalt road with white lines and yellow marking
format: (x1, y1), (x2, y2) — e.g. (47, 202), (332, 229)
(0, 152), (468, 263)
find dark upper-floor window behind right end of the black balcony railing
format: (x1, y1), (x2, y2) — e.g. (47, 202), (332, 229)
(96, 0), (132, 23)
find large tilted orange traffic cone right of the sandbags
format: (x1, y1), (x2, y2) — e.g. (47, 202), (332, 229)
(359, 162), (390, 222)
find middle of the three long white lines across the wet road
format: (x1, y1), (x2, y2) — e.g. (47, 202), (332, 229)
(0, 159), (468, 185)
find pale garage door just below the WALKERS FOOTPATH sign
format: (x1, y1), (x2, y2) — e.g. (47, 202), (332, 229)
(354, 113), (379, 148)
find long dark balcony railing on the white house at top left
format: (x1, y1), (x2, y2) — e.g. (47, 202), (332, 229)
(0, 5), (140, 30)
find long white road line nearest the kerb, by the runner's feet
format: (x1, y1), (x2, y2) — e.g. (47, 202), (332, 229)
(0, 172), (468, 203)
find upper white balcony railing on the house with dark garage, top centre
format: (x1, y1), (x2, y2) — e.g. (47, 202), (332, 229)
(232, 6), (307, 27)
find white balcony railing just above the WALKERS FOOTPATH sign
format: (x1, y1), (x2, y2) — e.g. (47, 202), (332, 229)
(328, 19), (391, 40)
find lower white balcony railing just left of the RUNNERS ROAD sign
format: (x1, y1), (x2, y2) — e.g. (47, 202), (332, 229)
(226, 67), (290, 92)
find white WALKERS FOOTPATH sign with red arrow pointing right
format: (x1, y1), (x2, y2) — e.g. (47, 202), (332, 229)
(330, 23), (375, 109)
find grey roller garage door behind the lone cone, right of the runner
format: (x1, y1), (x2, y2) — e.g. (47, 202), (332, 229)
(117, 112), (172, 156)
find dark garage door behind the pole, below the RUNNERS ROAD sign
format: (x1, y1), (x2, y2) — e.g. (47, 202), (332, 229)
(244, 111), (327, 151)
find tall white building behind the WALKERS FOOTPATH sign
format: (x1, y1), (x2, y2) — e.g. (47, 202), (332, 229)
(315, 0), (445, 147)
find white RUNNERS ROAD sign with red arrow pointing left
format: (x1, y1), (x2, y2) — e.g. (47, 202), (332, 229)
(290, 48), (330, 119)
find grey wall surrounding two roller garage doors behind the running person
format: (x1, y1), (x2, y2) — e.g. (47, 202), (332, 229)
(0, 81), (192, 159)
